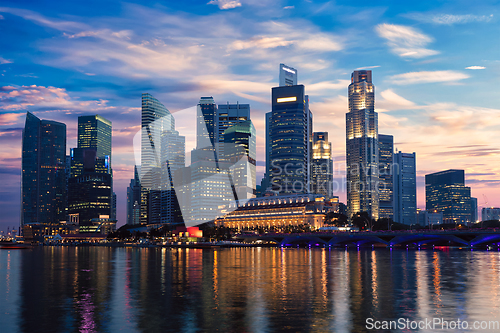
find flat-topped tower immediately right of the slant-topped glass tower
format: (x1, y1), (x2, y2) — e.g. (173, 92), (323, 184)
(160, 131), (186, 225)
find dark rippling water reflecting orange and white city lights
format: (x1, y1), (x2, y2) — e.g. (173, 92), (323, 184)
(0, 247), (500, 332)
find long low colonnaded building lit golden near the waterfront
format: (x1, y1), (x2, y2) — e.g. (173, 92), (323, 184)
(215, 194), (333, 229)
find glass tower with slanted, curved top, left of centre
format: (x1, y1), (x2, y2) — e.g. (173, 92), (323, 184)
(140, 93), (175, 224)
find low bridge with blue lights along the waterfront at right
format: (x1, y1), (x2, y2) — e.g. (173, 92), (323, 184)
(237, 230), (500, 247)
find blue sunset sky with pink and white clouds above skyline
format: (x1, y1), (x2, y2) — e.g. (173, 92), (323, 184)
(0, 0), (500, 230)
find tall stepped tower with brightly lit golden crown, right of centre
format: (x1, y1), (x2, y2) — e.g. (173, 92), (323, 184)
(346, 70), (379, 219)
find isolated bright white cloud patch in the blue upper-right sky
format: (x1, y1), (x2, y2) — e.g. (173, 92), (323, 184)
(375, 23), (439, 58)
